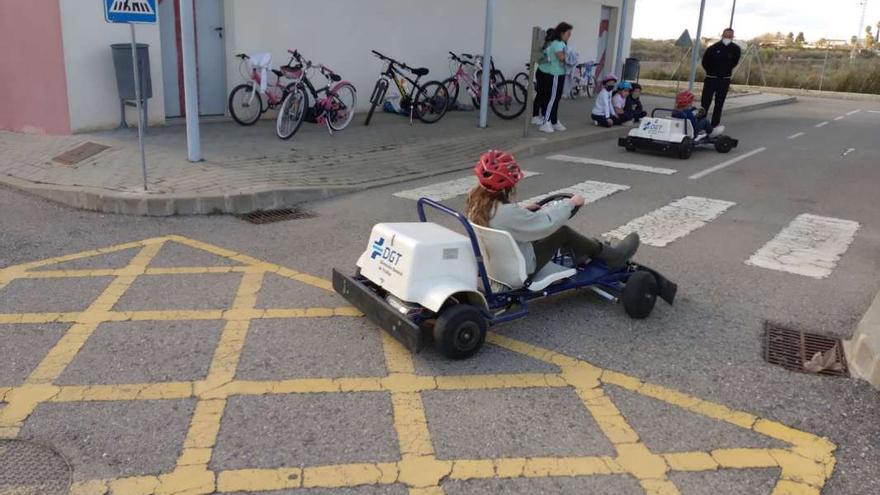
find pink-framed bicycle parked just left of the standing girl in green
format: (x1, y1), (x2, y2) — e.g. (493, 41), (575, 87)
(443, 52), (526, 120)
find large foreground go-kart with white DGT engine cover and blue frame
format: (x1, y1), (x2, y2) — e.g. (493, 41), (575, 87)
(333, 194), (677, 359)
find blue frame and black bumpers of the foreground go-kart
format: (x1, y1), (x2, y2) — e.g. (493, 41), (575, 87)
(333, 198), (678, 352)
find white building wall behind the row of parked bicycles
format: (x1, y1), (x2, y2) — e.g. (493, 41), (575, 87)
(220, 0), (635, 112)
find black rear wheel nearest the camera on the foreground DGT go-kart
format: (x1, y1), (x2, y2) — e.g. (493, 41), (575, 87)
(434, 304), (488, 359)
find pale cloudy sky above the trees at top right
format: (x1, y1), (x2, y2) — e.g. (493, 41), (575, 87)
(633, 0), (880, 41)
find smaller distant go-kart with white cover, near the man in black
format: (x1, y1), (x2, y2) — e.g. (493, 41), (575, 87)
(617, 108), (739, 159)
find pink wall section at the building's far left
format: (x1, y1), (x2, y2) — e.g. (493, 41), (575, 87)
(0, 0), (70, 134)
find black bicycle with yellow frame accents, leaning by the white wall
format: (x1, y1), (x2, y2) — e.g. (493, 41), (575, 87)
(364, 50), (449, 125)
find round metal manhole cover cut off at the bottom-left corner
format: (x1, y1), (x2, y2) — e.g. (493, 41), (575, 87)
(0, 440), (72, 495)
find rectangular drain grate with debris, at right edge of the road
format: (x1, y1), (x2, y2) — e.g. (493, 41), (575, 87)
(764, 322), (849, 376)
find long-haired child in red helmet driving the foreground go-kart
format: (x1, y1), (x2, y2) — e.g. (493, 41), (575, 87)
(467, 150), (639, 275)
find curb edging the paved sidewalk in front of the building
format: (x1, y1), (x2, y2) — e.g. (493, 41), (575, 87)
(0, 97), (797, 217)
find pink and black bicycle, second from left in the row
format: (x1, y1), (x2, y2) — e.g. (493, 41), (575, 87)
(275, 50), (357, 139)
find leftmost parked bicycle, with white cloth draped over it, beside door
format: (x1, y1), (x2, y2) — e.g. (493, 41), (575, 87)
(228, 53), (302, 126)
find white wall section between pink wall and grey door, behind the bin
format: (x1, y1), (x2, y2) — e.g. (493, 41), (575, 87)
(58, 0), (165, 132)
